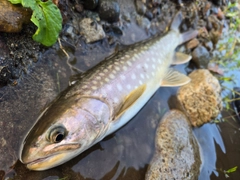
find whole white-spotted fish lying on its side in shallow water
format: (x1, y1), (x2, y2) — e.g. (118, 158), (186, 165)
(19, 12), (197, 171)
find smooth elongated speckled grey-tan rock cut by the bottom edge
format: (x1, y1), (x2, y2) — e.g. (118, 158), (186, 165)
(145, 110), (201, 180)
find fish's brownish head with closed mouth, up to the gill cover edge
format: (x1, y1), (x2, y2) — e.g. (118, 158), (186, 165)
(19, 97), (110, 171)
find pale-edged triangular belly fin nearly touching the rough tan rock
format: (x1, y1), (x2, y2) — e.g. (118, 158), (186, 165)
(161, 69), (191, 87)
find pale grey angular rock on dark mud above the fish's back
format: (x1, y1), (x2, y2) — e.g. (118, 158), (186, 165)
(79, 18), (106, 43)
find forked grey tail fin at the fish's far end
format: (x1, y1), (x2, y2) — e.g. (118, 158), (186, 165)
(171, 11), (198, 44)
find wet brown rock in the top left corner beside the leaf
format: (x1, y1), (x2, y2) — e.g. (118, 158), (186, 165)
(0, 0), (32, 33)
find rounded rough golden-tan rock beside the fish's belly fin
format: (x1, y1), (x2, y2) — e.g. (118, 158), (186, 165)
(177, 69), (222, 126)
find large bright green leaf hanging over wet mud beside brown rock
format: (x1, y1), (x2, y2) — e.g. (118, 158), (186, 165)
(31, 0), (62, 46)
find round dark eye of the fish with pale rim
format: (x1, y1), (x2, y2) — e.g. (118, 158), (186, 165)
(47, 125), (67, 143)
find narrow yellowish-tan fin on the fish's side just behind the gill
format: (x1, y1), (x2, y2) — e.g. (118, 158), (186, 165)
(114, 84), (146, 119)
